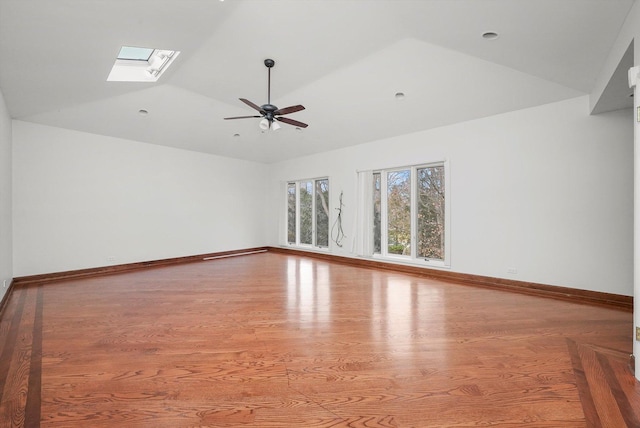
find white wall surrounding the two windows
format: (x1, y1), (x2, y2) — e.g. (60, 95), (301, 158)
(270, 96), (633, 295)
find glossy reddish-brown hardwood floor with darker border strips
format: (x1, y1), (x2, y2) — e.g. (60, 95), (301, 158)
(0, 252), (640, 428)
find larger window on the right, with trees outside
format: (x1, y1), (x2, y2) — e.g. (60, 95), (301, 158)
(372, 163), (449, 265)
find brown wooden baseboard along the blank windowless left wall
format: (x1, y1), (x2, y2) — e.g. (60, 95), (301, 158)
(13, 247), (268, 286)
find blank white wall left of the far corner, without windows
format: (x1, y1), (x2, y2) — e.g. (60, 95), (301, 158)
(13, 120), (267, 277)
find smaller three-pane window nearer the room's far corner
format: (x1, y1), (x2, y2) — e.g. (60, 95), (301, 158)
(287, 178), (329, 248)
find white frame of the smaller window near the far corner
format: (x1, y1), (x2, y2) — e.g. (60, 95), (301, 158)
(284, 176), (331, 251)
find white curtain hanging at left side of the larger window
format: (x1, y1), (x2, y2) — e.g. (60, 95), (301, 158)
(351, 171), (373, 256)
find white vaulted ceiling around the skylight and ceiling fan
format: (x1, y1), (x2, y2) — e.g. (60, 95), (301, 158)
(0, 0), (634, 163)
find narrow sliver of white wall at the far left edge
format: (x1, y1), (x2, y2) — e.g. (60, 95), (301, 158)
(0, 87), (13, 300)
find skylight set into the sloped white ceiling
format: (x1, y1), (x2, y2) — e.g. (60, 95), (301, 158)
(107, 46), (180, 82)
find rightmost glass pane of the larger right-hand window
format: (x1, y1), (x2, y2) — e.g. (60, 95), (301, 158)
(416, 165), (444, 260)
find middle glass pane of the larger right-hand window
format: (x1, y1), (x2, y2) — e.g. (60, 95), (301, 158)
(387, 169), (411, 255)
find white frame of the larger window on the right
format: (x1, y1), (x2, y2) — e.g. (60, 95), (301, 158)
(370, 160), (451, 268)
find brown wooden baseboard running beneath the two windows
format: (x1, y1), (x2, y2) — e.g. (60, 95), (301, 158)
(268, 247), (633, 312)
